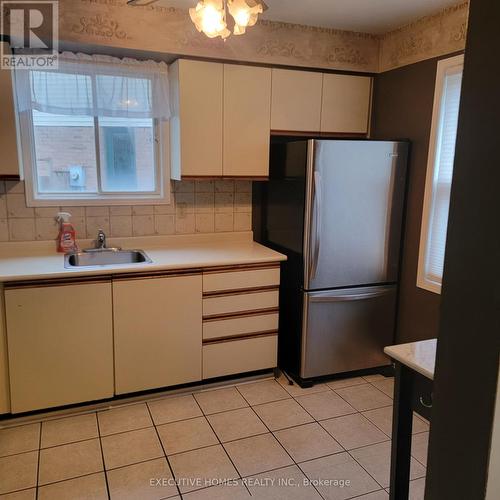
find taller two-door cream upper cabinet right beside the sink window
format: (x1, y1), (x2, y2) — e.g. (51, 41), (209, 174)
(170, 59), (271, 179)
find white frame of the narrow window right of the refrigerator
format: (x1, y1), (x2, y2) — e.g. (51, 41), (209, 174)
(417, 54), (464, 294)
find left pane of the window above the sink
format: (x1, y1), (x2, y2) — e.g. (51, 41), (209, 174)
(32, 111), (97, 193)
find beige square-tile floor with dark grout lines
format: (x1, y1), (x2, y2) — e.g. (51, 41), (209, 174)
(0, 375), (429, 500)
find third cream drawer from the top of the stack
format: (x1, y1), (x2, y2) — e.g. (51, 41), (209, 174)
(203, 313), (278, 340)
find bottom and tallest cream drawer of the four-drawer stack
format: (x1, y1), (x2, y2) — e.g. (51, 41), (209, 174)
(203, 335), (278, 379)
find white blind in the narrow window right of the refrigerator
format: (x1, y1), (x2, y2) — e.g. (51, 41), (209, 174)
(425, 66), (462, 285)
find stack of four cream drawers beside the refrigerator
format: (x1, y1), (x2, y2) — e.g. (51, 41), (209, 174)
(203, 264), (280, 379)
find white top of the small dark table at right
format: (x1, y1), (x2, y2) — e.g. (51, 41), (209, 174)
(384, 339), (437, 380)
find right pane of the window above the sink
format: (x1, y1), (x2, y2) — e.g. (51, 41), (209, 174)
(99, 117), (156, 192)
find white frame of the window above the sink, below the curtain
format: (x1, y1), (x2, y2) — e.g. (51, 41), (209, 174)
(16, 74), (171, 207)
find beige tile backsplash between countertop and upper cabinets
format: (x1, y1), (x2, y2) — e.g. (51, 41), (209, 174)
(0, 180), (252, 241)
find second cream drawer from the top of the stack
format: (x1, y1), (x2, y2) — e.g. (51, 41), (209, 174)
(203, 290), (279, 317)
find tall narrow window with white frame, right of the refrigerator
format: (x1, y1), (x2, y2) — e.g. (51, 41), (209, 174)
(417, 56), (463, 293)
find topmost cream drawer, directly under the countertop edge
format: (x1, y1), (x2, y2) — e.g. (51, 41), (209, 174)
(203, 266), (280, 292)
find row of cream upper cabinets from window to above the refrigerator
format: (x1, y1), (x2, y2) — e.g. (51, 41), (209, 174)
(170, 59), (372, 179)
